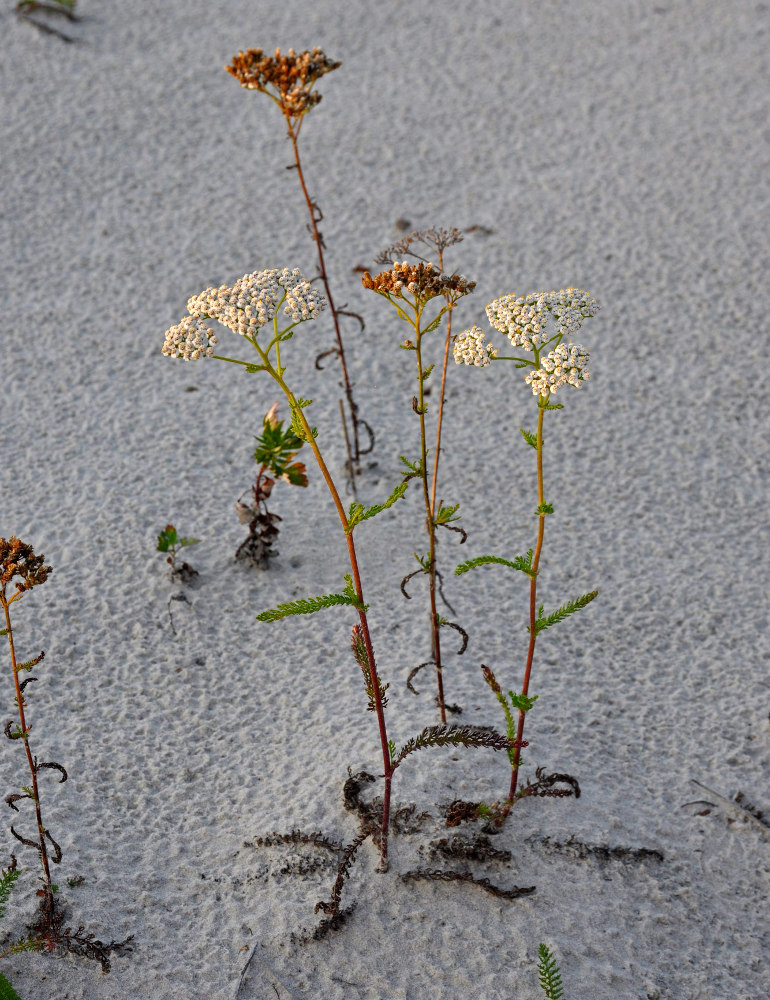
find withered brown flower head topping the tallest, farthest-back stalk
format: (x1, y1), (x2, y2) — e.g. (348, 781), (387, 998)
(225, 49), (341, 118)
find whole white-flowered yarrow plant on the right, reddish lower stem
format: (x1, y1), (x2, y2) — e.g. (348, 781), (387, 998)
(453, 288), (599, 824)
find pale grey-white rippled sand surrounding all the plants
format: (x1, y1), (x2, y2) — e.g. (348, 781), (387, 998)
(0, 0), (770, 1000)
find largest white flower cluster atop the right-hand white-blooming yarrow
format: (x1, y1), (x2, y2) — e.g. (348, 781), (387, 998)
(487, 288), (599, 351)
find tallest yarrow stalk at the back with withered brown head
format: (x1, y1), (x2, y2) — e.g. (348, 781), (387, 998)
(225, 48), (373, 484)
